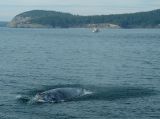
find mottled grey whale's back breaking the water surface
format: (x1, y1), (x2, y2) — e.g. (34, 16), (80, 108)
(26, 88), (93, 103)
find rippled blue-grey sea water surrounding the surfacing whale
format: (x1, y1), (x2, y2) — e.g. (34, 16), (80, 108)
(0, 28), (160, 119)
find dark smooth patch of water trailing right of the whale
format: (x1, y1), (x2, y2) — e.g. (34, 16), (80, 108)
(78, 87), (156, 101)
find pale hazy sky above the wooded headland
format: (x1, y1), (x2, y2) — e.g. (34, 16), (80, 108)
(0, 0), (160, 21)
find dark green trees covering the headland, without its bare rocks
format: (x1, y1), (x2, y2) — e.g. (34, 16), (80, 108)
(14, 10), (160, 28)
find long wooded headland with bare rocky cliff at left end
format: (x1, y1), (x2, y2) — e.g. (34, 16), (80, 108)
(8, 9), (160, 29)
